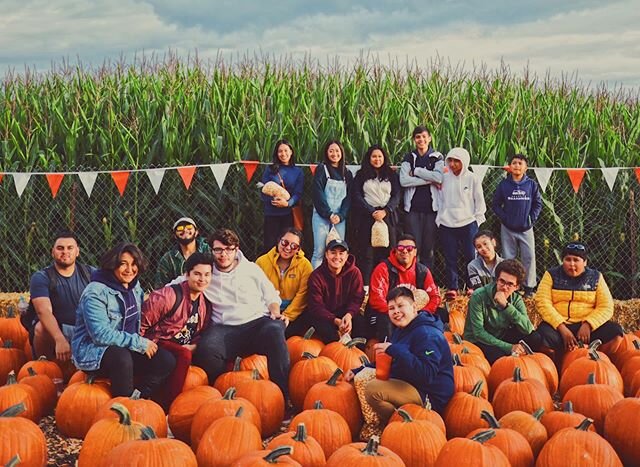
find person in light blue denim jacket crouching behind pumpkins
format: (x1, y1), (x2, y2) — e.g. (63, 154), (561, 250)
(71, 242), (175, 397)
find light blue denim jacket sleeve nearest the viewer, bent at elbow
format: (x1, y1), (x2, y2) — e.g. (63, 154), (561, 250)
(78, 289), (148, 353)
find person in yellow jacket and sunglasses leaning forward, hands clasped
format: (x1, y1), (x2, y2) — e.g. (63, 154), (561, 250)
(256, 227), (313, 337)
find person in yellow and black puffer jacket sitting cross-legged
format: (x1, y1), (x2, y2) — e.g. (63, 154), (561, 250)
(535, 242), (623, 354)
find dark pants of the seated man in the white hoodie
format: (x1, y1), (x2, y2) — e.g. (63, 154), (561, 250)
(193, 316), (289, 398)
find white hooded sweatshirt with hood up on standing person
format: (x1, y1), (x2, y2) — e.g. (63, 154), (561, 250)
(435, 148), (487, 228)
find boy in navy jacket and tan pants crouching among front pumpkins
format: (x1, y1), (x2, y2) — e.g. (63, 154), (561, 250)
(345, 286), (454, 425)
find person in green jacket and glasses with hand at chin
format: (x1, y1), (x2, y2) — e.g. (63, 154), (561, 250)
(464, 259), (542, 364)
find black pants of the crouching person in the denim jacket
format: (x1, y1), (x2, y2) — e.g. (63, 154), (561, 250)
(93, 346), (176, 398)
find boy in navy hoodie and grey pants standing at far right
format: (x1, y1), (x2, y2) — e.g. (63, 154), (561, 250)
(493, 154), (542, 296)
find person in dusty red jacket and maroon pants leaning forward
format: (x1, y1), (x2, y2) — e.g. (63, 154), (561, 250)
(140, 253), (213, 408)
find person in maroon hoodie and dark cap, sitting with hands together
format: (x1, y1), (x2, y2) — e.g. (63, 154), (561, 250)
(302, 240), (364, 343)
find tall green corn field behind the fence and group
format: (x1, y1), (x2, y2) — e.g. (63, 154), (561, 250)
(0, 57), (640, 298)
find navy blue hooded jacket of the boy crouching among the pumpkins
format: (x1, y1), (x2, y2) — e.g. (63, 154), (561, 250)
(386, 313), (453, 413)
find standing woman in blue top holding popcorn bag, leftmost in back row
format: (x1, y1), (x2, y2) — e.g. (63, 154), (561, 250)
(262, 139), (304, 252)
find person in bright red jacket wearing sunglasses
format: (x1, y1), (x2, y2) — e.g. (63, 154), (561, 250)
(366, 234), (440, 341)
